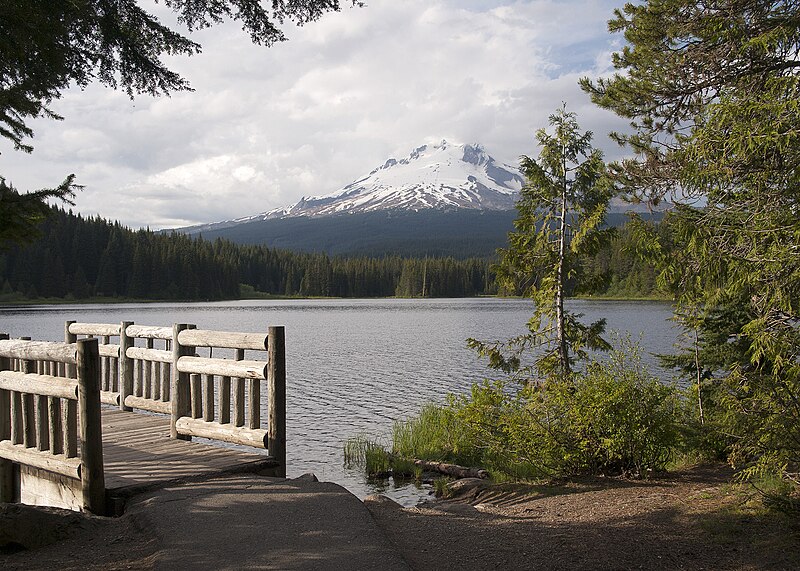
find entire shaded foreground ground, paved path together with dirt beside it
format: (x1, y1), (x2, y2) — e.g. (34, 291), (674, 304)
(0, 467), (800, 571)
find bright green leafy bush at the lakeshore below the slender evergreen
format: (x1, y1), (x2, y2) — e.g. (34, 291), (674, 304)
(394, 342), (685, 479)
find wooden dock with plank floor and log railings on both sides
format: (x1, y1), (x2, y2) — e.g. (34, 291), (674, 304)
(0, 321), (286, 515)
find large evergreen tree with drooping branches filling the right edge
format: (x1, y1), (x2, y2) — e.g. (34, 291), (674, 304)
(582, 0), (800, 500)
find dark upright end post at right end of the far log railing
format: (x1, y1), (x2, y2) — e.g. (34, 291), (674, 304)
(267, 327), (286, 478)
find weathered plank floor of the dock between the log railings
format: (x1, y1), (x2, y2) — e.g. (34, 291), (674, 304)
(102, 408), (279, 514)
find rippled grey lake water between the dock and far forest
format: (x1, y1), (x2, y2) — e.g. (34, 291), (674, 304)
(0, 299), (679, 505)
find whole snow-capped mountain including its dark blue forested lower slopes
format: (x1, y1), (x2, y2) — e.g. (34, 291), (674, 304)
(176, 140), (664, 258)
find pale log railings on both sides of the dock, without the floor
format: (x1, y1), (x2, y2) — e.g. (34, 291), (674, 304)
(0, 321), (286, 513)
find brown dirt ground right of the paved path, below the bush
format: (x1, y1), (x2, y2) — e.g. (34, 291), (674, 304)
(366, 466), (800, 570)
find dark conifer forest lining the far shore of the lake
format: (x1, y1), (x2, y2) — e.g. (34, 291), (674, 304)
(0, 209), (657, 302)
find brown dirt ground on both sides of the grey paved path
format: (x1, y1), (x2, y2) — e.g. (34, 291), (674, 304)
(0, 466), (800, 571)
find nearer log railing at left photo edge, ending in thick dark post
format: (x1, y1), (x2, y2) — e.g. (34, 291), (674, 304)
(0, 335), (105, 514)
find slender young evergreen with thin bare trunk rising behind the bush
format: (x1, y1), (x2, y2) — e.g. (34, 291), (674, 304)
(470, 106), (612, 378)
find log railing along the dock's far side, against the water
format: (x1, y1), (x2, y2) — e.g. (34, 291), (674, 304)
(65, 321), (286, 476)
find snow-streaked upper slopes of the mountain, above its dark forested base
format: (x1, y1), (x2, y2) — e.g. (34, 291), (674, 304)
(241, 141), (523, 222)
